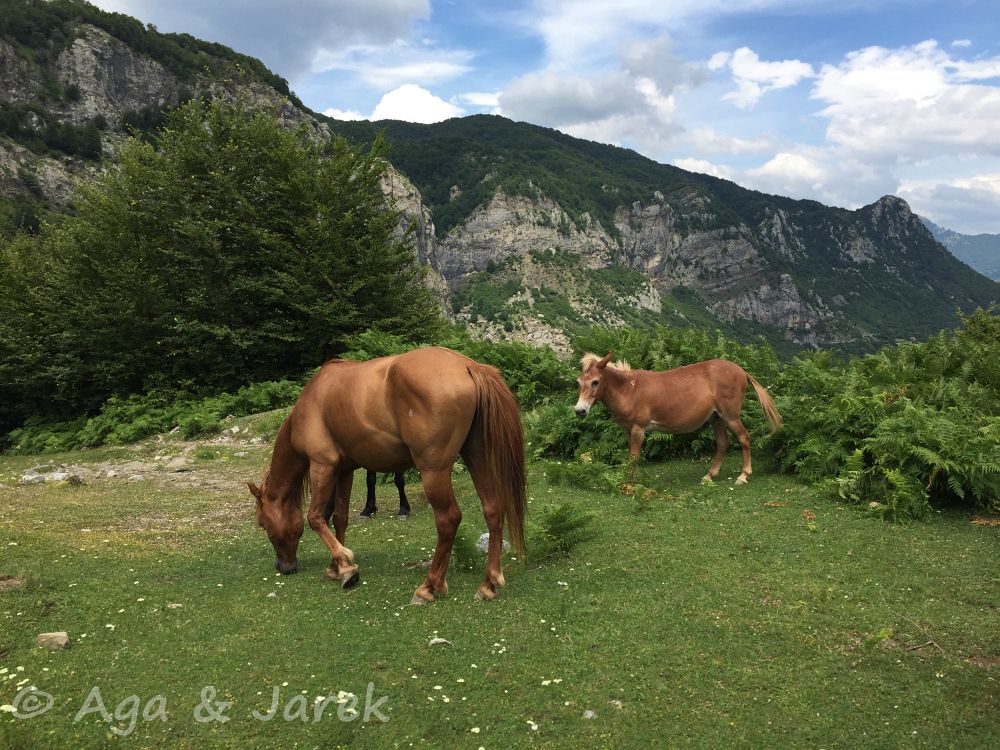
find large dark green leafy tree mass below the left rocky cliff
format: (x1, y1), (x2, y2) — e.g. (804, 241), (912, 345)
(0, 101), (440, 434)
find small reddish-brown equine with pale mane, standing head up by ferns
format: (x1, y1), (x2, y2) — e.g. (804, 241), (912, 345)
(575, 352), (781, 484)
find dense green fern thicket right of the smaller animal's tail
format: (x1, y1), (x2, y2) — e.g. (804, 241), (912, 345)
(764, 310), (1000, 519)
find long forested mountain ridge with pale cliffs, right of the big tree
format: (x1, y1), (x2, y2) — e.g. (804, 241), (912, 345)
(326, 115), (1000, 350)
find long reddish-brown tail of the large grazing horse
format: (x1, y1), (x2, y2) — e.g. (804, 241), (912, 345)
(469, 363), (527, 555)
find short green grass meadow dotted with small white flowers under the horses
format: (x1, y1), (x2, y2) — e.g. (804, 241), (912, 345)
(0, 445), (1000, 748)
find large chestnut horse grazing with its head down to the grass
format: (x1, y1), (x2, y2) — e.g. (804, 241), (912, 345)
(248, 348), (525, 604)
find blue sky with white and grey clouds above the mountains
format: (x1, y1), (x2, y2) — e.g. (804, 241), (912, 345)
(95, 0), (1000, 234)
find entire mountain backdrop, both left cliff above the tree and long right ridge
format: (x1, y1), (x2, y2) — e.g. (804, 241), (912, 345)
(0, 0), (1000, 351)
